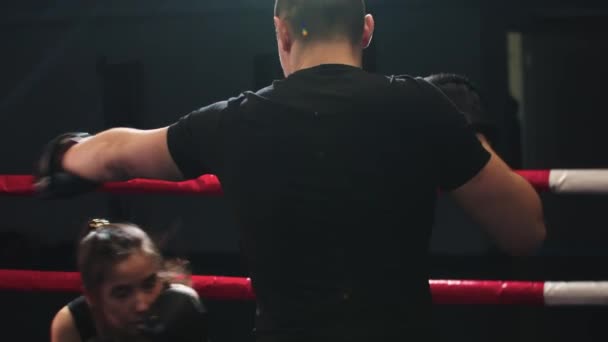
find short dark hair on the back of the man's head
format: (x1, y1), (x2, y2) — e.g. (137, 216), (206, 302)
(274, 0), (365, 44)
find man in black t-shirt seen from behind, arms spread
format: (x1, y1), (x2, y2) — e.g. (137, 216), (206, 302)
(37, 0), (545, 341)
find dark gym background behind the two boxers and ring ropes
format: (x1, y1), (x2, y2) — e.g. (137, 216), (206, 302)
(0, 0), (608, 342)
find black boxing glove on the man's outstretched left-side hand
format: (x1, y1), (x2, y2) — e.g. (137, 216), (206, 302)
(34, 133), (100, 198)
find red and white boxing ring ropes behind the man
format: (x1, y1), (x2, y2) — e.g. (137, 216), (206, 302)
(0, 169), (608, 306)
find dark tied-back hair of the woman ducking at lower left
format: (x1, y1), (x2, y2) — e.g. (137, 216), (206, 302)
(77, 219), (189, 291)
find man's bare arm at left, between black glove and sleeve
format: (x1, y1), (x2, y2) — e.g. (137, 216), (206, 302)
(62, 127), (183, 182)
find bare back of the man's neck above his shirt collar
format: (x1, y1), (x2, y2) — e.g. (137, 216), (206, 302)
(291, 42), (363, 73)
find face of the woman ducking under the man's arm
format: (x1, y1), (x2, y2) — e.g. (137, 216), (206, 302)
(92, 253), (163, 334)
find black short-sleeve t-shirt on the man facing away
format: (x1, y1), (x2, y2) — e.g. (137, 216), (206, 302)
(168, 65), (489, 341)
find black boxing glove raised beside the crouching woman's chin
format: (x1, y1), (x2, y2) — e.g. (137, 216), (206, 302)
(140, 285), (207, 342)
